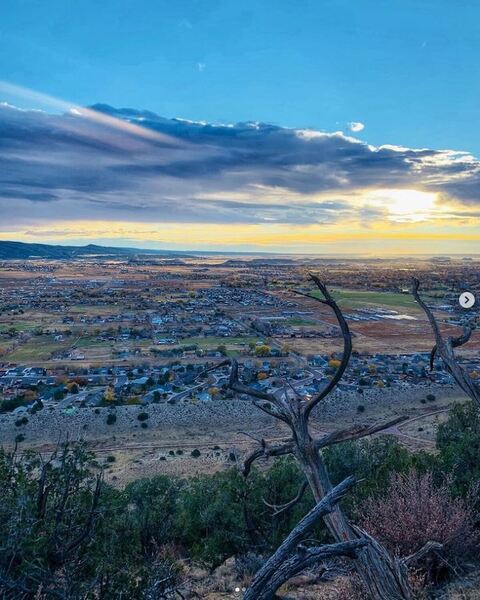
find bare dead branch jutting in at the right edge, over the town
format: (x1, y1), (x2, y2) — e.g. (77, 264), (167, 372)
(412, 278), (480, 406)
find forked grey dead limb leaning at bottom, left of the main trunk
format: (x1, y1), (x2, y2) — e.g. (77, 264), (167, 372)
(244, 477), (368, 600)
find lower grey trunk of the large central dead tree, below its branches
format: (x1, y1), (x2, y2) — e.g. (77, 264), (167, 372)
(295, 434), (413, 600)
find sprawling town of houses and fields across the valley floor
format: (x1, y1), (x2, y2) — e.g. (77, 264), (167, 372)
(0, 256), (480, 454)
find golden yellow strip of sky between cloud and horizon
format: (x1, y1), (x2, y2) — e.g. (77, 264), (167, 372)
(0, 214), (480, 255)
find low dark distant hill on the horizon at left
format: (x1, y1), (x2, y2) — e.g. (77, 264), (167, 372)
(0, 241), (192, 260)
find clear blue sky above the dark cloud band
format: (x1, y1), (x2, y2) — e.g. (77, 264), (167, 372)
(0, 0), (480, 156)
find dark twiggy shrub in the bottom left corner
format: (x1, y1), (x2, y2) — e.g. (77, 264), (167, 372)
(0, 445), (102, 598)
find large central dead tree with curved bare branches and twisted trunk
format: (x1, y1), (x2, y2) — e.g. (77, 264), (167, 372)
(213, 275), (413, 600)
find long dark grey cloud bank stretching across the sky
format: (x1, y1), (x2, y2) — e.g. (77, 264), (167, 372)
(0, 105), (480, 224)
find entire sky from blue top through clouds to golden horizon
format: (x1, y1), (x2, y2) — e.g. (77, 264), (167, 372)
(0, 0), (480, 255)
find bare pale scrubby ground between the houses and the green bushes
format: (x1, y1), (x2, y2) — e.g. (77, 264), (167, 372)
(0, 385), (463, 485)
